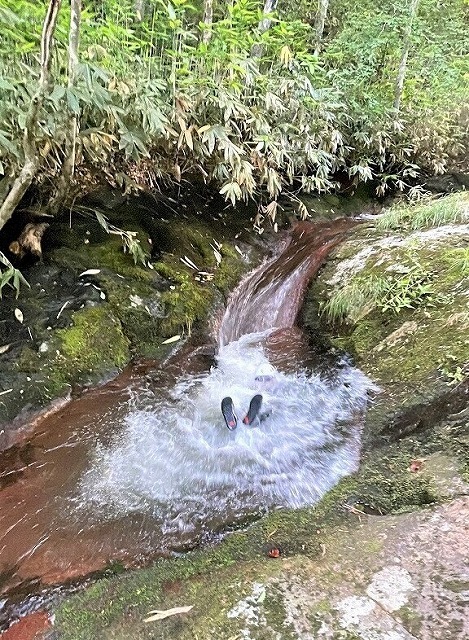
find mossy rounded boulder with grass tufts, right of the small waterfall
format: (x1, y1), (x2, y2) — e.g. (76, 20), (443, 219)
(303, 194), (469, 442)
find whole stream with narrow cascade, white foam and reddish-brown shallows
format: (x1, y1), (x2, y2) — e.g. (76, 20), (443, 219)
(0, 222), (371, 628)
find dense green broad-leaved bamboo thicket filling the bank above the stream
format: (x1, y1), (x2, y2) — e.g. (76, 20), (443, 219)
(0, 0), (469, 214)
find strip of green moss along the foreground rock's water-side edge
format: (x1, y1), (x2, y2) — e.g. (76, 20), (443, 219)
(57, 432), (437, 640)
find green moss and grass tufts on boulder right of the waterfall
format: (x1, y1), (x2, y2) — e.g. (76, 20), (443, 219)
(304, 229), (469, 384)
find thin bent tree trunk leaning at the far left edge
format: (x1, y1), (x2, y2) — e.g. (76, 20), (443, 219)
(0, 0), (62, 234)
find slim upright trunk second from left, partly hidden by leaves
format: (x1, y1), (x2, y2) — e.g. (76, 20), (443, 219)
(47, 0), (81, 214)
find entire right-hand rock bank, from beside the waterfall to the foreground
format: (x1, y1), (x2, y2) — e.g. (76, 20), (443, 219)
(18, 192), (469, 640)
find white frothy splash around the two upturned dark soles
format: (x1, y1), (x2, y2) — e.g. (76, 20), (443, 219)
(80, 332), (370, 533)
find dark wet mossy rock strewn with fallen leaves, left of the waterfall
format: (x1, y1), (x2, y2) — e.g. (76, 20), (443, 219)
(0, 192), (260, 450)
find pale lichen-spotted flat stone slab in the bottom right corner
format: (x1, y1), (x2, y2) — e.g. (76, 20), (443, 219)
(220, 496), (469, 640)
